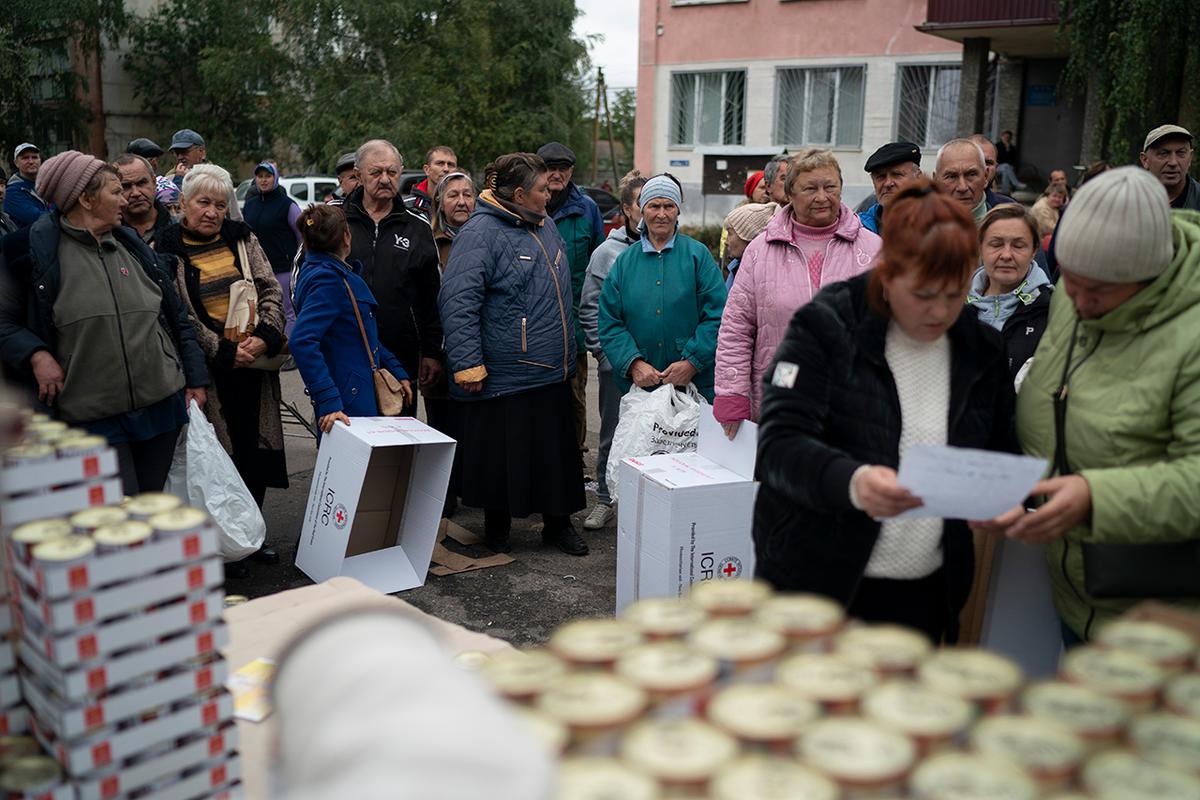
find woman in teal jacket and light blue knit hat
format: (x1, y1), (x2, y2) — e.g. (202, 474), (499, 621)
(599, 175), (726, 402)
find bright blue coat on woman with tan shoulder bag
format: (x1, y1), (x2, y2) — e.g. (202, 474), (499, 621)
(288, 253), (408, 416)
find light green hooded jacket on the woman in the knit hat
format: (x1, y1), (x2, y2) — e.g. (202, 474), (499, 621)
(1016, 211), (1200, 639)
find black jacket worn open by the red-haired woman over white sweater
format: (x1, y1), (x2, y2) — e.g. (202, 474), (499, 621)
(754, 273), (1016, 638)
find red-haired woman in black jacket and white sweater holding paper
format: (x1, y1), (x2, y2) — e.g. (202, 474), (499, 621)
(754, 181), (1015, 643)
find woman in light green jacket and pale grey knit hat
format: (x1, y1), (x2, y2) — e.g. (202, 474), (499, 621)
(974, 167), (1200, 645)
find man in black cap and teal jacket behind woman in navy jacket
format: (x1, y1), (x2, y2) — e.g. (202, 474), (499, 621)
(538, 142), (604, 450)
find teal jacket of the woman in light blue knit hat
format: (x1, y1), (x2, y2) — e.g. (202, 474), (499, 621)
(598, 234), (725, 402)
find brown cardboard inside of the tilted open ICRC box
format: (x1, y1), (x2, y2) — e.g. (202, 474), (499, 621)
(346, 445), (420, 558)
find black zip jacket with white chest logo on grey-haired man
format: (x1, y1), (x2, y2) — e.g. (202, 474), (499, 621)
(341, 186), (443, 377)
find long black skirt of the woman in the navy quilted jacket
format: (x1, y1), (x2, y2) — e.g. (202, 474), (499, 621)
(450, 381), (586, 517)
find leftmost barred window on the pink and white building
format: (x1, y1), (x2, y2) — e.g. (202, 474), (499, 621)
(671, 71), (746, 145)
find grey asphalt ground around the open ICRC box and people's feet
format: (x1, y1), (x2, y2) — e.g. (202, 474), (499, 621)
(226, 357), (617, 645)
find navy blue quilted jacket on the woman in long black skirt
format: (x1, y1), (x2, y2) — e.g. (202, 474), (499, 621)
(438, 190), (576, 401)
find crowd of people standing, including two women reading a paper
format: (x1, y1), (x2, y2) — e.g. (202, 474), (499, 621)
(0, 118), (1200, 644)
